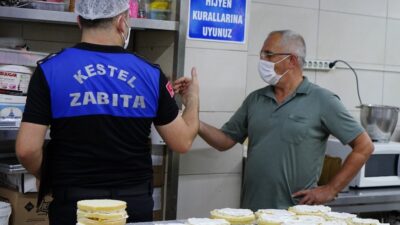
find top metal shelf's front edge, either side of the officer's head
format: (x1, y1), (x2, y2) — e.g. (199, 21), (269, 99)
(0, 6), (179, 31)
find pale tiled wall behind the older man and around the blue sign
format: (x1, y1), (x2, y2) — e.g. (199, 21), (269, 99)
(178, 0), (400, 218)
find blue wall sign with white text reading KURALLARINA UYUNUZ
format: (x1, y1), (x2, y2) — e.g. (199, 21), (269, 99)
(188, 0), (246, 43)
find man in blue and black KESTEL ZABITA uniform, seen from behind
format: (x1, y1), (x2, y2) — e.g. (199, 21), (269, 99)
(16, 0), (199, 225)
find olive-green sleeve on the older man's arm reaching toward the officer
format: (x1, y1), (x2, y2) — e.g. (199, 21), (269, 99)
(221, 97), (249, 143)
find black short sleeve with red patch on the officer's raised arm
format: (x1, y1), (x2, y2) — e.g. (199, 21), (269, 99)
(153, 71), (179, 126)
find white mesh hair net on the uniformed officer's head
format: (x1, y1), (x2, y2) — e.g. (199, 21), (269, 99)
(75, 0), (129, 20)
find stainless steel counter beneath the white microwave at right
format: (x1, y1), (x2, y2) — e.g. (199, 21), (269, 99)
(327, 187), (400, 213)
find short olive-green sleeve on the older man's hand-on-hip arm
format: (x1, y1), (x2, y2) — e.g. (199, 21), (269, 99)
(322, 95), (364, 144)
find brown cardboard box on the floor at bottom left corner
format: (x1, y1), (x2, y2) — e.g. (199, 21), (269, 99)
(0, 187), (51, 225)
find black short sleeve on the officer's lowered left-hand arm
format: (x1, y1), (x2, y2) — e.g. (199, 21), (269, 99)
(22, 65), (52, 125)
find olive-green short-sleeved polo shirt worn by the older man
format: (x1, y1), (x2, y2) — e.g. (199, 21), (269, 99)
(221, 77), (364, 210)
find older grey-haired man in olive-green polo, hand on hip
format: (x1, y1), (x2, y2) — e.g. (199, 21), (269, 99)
(175, 30), (373, 210)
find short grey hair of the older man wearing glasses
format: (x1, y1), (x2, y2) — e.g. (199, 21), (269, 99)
(268, 30), (306, 68)
